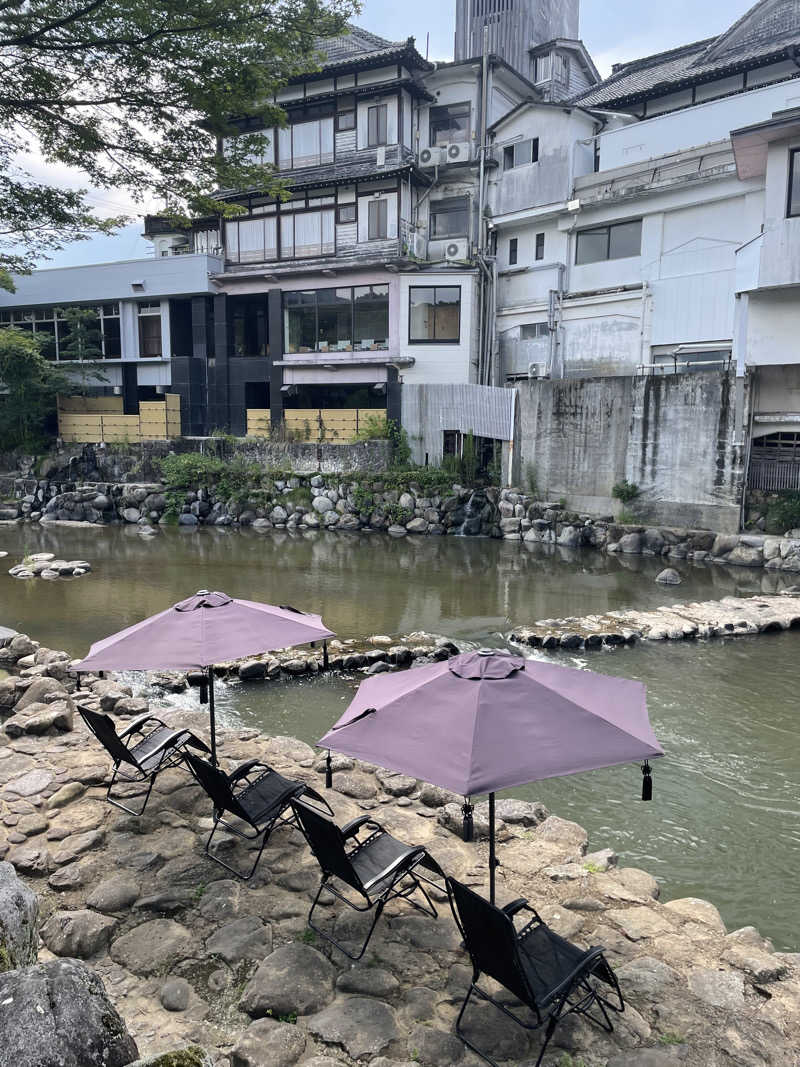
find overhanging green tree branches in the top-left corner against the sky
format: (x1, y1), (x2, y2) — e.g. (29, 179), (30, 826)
(0, 0), (358, 288)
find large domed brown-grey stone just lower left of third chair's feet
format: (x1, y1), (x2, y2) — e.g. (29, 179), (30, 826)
(239, 941), (336, 1019)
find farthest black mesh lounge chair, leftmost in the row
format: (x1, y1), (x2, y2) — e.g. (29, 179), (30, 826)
(78, 707), (208, 815)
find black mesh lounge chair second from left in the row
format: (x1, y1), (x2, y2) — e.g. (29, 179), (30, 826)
(186, 752), (333, 881)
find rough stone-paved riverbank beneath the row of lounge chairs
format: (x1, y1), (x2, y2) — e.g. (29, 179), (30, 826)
(0, 638), (800, 1067)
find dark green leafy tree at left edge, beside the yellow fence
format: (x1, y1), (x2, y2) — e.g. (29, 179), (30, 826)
(0, 327), (69, 451)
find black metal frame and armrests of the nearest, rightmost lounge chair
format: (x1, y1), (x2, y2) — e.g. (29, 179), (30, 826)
(447, 877), (625, 1067)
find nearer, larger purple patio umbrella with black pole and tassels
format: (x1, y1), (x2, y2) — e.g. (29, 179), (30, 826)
(318, 651), (663, 901)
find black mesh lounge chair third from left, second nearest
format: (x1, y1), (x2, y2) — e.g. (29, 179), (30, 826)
(292, 800), (444, 959)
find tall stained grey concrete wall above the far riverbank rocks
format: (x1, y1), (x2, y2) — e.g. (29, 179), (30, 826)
(515, 371), (742, 530)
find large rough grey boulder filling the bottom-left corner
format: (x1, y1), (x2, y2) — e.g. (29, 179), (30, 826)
(0, 959), (139, 1067)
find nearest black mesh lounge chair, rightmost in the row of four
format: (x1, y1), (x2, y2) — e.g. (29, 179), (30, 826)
(447, 878), (625, 1067)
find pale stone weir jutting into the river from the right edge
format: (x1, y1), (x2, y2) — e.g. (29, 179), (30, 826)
(509, 590), (800, 650)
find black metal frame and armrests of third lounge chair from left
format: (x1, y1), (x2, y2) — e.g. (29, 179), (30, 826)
(292, 800), (445, 961)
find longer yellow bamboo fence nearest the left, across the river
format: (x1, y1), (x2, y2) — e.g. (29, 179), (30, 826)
(59, 393), (180, 444)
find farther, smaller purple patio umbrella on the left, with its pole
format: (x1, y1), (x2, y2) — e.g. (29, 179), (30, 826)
(76, 589), (334, 766)
